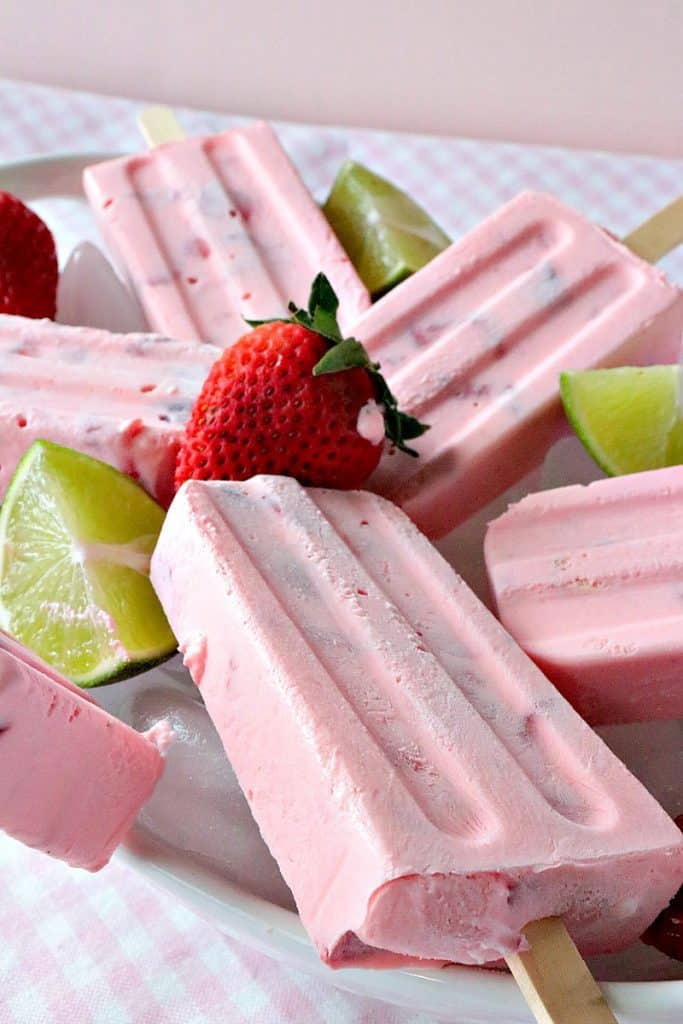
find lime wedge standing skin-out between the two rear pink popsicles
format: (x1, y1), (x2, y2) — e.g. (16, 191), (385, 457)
(323, 160), (451, 299)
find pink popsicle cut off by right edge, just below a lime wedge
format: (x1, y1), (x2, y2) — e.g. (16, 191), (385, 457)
(484, 466), (683, 725)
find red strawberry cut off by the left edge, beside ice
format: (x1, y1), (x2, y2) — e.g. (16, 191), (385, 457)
(0, 191), (58, 319)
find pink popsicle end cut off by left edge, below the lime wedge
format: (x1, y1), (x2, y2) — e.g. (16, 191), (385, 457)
(0, 631), (170, 871)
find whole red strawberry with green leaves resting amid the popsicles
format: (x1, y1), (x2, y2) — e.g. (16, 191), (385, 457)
(175, 274), (427, 488)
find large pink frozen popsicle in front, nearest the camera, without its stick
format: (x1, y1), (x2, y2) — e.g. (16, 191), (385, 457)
(152, 476), (683, 967)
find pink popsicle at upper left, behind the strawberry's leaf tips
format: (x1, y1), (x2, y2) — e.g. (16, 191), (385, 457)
(83, 122), (370, 348)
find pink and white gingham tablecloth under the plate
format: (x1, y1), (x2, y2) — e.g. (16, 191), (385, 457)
(0, 82), (683, 1024)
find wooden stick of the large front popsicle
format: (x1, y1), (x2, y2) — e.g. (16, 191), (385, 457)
(507, 918), (617, 1024)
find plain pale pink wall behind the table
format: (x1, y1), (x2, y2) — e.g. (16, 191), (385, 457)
(0, 0), (683, 157)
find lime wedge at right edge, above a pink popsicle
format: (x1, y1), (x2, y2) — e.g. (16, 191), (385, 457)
(560, 366), (683, 476)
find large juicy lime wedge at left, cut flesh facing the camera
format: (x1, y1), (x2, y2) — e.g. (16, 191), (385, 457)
(0, 441), (176, 686)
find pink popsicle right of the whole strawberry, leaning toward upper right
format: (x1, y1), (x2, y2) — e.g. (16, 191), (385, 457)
(351, 193), (683, 537)
